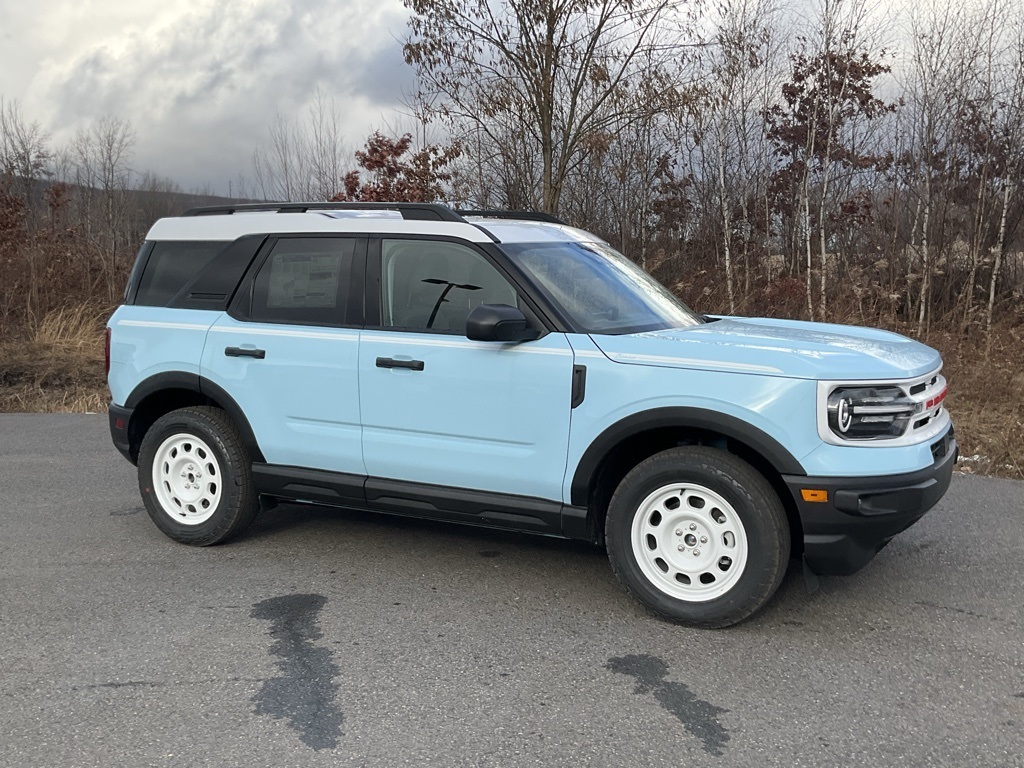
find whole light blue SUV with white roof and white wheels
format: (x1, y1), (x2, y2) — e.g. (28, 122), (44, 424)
(108, 203), (957, 627)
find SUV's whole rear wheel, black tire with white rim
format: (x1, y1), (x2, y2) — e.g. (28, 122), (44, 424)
(138, 407), (259, 547)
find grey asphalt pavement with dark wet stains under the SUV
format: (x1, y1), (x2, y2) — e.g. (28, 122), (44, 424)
(0, 415), (1024, 768)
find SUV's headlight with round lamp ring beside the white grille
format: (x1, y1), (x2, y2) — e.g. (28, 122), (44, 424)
(828, 387), (922, 440)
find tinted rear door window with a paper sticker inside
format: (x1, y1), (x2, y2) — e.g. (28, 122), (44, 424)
(250, 238), (355, 325)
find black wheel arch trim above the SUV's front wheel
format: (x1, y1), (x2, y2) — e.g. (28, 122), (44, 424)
(570, 406), (807, 506)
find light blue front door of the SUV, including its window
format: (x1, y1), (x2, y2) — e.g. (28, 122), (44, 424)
(359, 239), (573, 502)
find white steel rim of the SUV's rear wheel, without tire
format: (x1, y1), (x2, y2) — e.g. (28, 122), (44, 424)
(153, 432), (223, 525)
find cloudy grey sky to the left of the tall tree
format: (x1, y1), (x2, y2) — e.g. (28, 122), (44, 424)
(0, 0), (412, 194)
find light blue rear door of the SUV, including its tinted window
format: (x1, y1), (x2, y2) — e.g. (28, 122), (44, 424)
(203, 236), (366, 475)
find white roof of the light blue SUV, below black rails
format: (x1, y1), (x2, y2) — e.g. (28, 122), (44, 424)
(146, 210), (600, 243)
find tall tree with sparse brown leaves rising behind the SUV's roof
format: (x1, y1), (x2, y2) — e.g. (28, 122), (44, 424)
(403, 0), (681, 212)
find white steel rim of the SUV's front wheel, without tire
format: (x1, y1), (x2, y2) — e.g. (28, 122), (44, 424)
(631, 483), (748, 602)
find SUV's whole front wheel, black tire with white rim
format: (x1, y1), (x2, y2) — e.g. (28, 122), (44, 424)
(605, 445), (791, 629)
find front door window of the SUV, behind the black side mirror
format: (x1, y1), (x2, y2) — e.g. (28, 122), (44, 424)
(381, 240), (517, 334)
